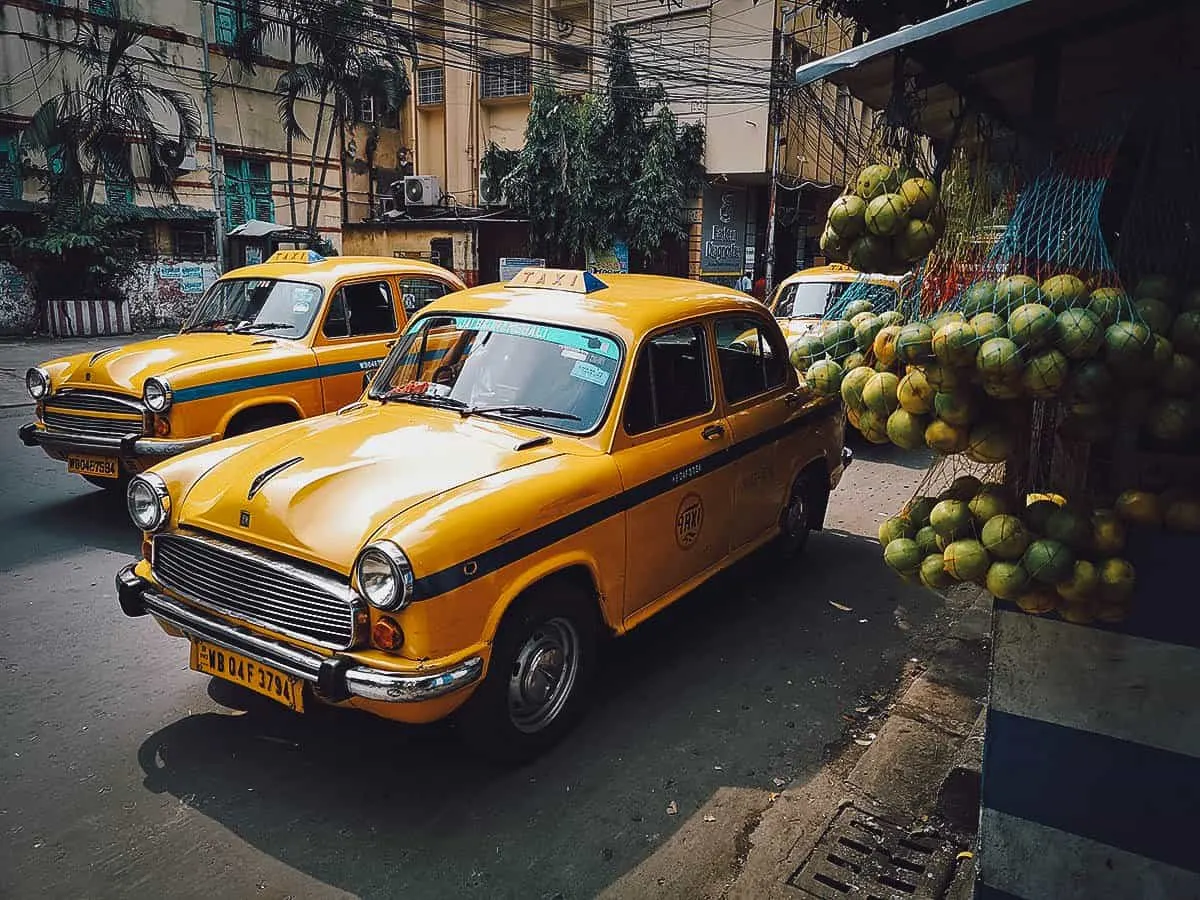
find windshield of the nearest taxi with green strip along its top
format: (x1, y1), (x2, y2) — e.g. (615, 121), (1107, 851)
(370, 313), (622, 434)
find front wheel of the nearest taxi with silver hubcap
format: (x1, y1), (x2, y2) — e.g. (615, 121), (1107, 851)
(457, 578), (600, 763)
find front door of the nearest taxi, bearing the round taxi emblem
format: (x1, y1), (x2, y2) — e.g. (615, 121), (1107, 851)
(613, 320), (732, 618)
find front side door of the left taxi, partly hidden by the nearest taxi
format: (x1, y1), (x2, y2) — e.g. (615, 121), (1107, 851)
(313, 277), (403, 413)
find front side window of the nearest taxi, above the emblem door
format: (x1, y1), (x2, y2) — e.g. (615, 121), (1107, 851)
(624, 326), (713, 434)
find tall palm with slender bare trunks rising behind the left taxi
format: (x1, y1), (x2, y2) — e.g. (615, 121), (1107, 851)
(275, 0), (416, 234)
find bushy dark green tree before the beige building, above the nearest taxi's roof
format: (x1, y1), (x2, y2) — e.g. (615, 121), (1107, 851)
(484, 26), (704, 268)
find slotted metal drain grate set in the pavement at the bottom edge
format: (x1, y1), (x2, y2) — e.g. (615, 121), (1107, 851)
(787, 806), (955, 900)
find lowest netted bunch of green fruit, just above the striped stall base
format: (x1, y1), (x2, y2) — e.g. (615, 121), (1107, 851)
(878, 475), (1135, 623)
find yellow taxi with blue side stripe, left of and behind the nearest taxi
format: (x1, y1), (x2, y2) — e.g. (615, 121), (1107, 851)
(20, 250), (466, 490)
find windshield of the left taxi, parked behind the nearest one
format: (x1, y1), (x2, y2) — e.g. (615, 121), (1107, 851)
(184, 278), (322, 337)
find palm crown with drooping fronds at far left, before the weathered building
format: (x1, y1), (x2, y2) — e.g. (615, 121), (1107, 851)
(23, 12), (200, 205)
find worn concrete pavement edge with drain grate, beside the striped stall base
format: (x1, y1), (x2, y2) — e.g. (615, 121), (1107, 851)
(601, 587), (991, 900)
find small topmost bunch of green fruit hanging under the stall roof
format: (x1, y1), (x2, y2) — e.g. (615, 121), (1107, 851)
(821, 163), (946, 275)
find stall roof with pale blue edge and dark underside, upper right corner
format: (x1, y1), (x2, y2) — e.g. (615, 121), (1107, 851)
(796, 0), (1200, 138)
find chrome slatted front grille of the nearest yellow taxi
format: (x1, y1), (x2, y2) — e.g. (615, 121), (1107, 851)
(151, 534), (365, 650)
